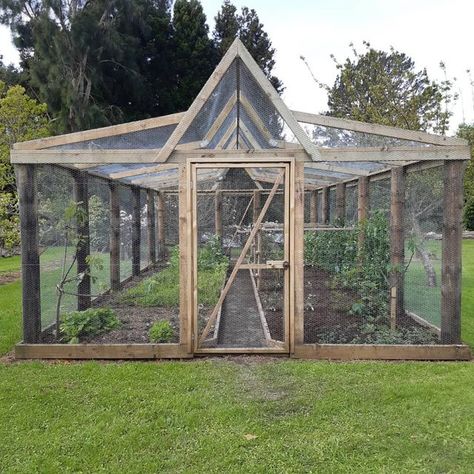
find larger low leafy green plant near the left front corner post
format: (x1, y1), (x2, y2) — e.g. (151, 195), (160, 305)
(60, 308), (121, 344)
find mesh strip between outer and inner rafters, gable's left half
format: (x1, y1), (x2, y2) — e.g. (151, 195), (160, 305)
(179, 60), (237, 148)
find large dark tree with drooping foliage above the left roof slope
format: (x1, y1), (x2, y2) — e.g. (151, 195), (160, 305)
(0, 0), (176, 131)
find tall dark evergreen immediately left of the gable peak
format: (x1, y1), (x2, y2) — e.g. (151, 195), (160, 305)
(173, 0), (217, 110)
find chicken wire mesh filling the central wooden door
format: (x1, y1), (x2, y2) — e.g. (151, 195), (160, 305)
(195, 168), (285, 348)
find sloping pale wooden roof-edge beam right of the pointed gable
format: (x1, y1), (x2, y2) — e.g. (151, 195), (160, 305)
(292, 110), (467, 145)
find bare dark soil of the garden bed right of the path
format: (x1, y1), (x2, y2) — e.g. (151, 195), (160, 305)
(260, 267), (439, 344)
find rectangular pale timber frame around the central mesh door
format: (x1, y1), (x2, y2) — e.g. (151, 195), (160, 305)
(185, 157), (295, 355)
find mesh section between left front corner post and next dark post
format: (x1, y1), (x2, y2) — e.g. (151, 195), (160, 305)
(36, 165), (77, 332)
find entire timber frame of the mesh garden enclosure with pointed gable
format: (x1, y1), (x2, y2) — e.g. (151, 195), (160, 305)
(11, 40), (471, 360)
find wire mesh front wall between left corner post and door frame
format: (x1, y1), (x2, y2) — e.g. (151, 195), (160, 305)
(30, 166), (180, 344)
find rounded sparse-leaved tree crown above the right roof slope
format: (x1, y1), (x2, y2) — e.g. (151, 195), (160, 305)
(327, 42), (453, 134)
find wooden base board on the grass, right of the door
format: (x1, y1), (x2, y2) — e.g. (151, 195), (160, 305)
(295, 344), (471, 360)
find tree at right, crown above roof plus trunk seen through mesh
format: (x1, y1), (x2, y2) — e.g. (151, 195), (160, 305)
(319, 42), (455, 286)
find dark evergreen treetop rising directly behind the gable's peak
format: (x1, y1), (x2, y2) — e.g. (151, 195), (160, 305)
(213, 0), (283, 93)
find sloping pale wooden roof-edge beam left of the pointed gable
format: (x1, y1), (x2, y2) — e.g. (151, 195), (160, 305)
(13, 112), (185, 150)
